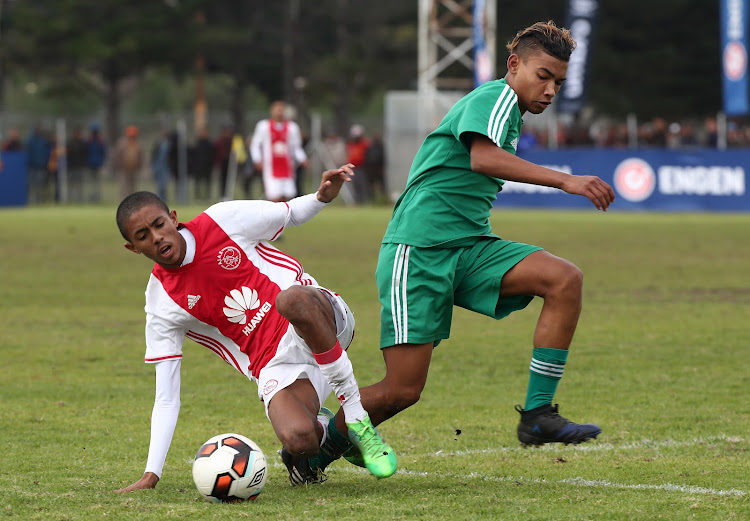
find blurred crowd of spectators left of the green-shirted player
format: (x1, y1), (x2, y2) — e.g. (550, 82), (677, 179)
(0, 117), (385, 204)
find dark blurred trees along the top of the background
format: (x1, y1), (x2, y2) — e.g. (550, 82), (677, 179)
(0, 0), (721, 142)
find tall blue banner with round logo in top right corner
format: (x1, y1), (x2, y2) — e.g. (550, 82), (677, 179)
(720, 0), (750, 116)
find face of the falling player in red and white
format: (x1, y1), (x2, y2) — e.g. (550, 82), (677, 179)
(125, 204), (186, 268)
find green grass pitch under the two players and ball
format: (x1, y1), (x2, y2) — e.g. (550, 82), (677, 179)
(0, 206), (750, 521)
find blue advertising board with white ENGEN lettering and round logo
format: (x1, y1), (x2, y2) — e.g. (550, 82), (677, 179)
(495, 148), (750, 212)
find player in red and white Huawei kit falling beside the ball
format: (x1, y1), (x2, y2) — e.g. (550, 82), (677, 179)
(117, 164), (397, 492)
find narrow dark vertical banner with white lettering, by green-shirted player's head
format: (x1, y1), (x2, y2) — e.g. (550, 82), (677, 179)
(555, 0), (599, 113)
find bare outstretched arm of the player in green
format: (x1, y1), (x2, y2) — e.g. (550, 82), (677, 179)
(471, 134), (615, 212)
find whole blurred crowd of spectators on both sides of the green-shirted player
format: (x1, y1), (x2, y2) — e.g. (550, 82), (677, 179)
(0, 112), (750, 204)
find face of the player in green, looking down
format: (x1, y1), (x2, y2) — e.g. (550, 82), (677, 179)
(506, 51), (568, 114)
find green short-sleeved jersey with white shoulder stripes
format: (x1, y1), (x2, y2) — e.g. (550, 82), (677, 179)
(383, 79), (523, 247)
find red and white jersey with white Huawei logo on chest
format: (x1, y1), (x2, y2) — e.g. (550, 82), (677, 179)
(145, 201), (316, 380)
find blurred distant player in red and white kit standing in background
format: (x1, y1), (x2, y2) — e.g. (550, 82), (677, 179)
(250, 101), (307, 202)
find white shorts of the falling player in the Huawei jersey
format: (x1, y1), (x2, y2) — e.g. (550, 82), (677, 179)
(258, 286), (354, 419)
